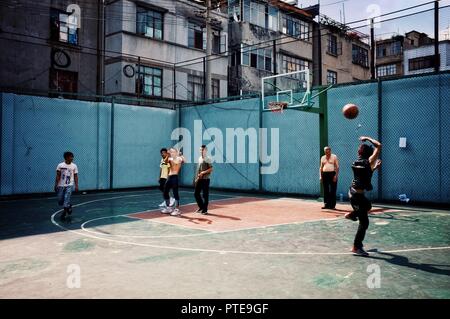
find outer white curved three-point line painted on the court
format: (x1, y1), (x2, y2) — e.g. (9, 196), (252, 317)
(51, 195), (450, 256)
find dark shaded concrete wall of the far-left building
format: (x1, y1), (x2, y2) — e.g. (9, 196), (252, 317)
(0, 0), (97, 94)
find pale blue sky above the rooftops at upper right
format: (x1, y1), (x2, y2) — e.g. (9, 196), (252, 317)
(299, 0), (450, 38)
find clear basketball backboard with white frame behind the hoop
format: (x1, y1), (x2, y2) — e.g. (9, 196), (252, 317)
(261, 69), (314, 112)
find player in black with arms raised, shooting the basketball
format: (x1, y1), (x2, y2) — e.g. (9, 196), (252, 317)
(345, 136), (381, 256)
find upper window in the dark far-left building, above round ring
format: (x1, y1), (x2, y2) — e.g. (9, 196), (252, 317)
(50, 9), (78, 45)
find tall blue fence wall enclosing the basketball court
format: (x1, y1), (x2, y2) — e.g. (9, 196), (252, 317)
(0, 72), (450, 203)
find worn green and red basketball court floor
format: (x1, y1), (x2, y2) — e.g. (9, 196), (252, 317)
(0, 189), (450, 299)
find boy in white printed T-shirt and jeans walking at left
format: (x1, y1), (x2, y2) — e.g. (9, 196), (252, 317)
(55, 152), (78, 220)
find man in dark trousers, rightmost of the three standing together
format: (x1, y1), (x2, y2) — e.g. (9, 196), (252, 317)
(194, 145), (213, 215)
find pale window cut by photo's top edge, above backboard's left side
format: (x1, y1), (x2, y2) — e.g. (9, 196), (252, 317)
(243, 0), (278, 31)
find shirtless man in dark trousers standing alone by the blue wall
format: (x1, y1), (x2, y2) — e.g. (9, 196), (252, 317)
(320, 146), (339, 209)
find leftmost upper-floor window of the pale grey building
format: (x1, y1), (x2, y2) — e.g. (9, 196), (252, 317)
(136, 7), (163, 40)
